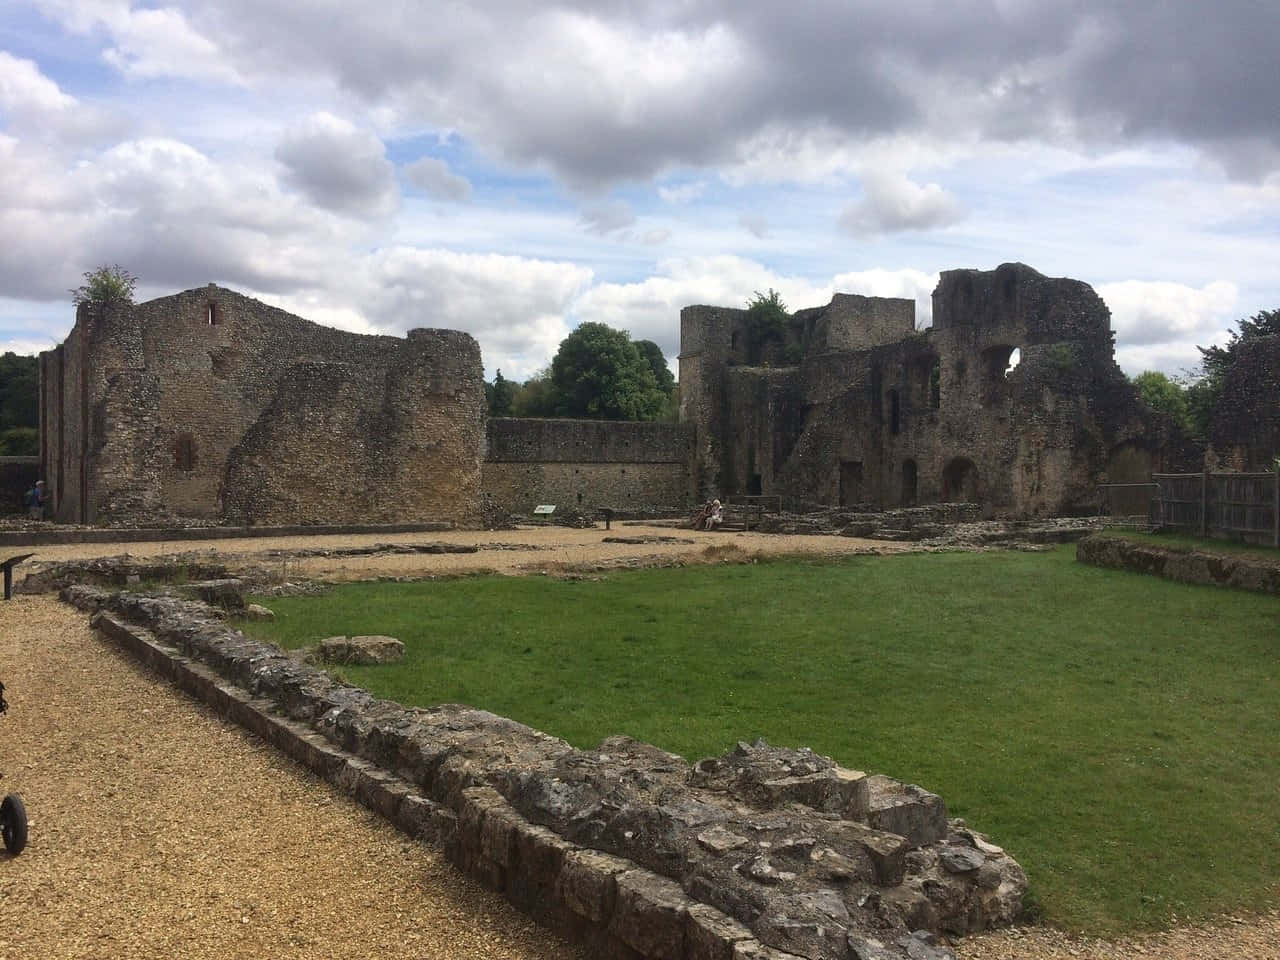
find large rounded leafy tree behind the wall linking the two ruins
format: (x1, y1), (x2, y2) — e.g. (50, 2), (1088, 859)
(552, 323), (666, 420)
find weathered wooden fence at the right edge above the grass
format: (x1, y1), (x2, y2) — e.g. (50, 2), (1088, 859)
(1151, 471), (1280, 547)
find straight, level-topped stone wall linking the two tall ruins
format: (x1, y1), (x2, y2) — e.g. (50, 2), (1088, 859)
(481, 417), (692, 513)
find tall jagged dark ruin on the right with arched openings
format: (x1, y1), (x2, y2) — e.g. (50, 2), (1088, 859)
(680, 264), (1183, 516)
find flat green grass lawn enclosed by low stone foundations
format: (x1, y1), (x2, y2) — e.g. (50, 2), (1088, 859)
(244, 547), (1280, 933)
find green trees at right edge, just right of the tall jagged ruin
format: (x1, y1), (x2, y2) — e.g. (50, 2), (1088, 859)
(1133, 310), (1280, 439)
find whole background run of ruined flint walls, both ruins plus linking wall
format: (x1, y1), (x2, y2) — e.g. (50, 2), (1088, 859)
(40, 264), (1198, 526)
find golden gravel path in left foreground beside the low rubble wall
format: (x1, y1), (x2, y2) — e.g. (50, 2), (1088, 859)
(0, 596), (585, 960)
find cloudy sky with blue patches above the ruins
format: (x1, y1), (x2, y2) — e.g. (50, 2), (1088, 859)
(0, 0), (1280, 378)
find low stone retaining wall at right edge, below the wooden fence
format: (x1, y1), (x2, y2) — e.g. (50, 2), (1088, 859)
(1075, 535), (1280, 595)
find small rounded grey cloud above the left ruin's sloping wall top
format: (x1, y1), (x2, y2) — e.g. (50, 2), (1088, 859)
(275, 111), (399, 218)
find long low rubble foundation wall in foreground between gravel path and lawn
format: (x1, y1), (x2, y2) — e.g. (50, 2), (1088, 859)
(52, 584), (1025, 960)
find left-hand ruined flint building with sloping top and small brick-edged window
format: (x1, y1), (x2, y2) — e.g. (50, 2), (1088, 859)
(40, 284), (484, 525)
